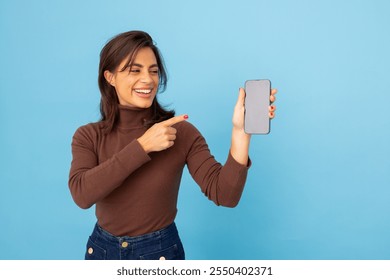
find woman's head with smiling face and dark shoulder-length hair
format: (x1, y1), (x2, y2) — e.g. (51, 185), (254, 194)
(98, 31), (175, 132)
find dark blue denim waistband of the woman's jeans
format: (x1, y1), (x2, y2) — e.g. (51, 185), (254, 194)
(92, 223), (178, 243)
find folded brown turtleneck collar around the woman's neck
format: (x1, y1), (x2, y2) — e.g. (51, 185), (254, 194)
(118, 104), (153, 128)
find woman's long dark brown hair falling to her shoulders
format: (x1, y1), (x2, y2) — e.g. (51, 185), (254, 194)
(98, 31), (175, 133)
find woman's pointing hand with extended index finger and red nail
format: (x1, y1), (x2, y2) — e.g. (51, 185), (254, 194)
(137, 115), (188, 153)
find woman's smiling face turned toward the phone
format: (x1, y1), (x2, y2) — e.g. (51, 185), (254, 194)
(104, 47), (159, 108)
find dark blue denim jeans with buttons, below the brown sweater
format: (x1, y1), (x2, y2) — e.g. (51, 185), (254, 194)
(85, 223), (185, 260)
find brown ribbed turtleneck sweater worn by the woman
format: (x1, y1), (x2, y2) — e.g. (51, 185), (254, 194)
(69, 106), (248, 236)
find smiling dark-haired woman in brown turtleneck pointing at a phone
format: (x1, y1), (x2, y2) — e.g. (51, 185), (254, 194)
(69, 31), (276, 259)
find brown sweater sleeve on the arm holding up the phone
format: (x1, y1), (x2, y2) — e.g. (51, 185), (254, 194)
(183, 123), (250, 207)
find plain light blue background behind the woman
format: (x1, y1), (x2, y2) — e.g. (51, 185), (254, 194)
(0, 0), (390, 259)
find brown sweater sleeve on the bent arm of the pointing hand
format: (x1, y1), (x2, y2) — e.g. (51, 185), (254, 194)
(69, 126), (150, 208)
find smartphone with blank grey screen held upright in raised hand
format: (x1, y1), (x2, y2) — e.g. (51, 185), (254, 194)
(244, 80), (271, 134)
